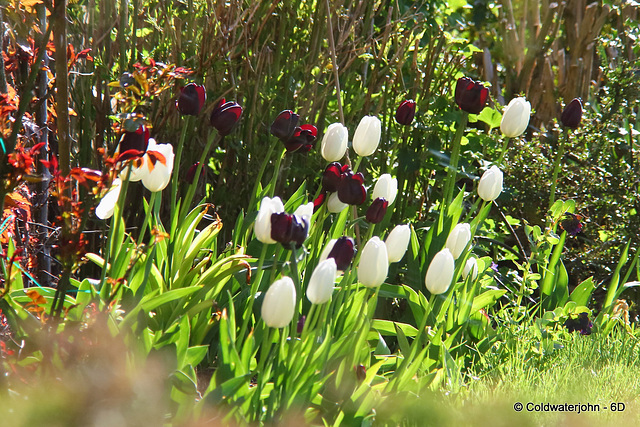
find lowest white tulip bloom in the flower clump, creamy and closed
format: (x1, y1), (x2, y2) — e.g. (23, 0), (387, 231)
(261, 276), (296, 328)
